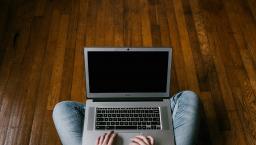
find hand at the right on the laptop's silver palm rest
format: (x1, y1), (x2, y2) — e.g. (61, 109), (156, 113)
(129, 135), (154, 145)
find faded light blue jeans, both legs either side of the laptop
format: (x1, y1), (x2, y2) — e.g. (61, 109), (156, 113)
(53, 91), (200, 145)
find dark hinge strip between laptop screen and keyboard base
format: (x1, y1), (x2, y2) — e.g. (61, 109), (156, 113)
(92, 98), (168, 102)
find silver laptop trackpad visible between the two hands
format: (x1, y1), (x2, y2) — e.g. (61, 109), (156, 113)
(115, 132), (141, 145)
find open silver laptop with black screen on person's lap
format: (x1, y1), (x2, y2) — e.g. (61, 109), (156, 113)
(82, 48), (175, 145)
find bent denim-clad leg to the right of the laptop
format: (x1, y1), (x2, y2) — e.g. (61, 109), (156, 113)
(171, 91), (200, 145)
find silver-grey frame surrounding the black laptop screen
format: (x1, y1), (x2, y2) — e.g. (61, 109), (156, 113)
(84, 47), (172, 98)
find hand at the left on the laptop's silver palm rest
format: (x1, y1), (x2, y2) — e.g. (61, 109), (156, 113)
(96, 131), (117, 145)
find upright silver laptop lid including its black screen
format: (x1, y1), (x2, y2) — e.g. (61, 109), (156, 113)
(84, 48), (172, 99)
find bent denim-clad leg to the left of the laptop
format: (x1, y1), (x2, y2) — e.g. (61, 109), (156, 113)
(53, 101), (85, 145)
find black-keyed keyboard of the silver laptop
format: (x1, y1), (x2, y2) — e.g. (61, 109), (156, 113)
(95, 107), (161, 130)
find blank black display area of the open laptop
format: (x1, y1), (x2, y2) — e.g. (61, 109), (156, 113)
(88, 51), (169, 93)
